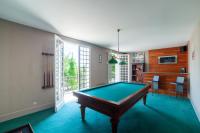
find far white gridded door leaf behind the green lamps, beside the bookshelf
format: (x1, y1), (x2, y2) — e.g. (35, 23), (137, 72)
(119, 54), (129, 82)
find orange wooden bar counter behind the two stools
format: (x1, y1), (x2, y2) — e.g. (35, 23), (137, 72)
(143, 72), (189, 97)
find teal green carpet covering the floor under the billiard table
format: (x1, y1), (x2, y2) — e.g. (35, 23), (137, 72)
(0, 94), (200, 133)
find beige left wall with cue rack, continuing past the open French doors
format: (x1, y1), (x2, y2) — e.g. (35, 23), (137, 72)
(0, 19), (108, 122)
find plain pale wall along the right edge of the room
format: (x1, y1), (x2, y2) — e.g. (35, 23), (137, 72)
(189, 23), (200, 120)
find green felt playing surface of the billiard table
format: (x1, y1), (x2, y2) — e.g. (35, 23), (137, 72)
(81, 82), (145, 102)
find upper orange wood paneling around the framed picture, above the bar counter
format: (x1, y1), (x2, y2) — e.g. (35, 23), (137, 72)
(149, 47), (188, 73)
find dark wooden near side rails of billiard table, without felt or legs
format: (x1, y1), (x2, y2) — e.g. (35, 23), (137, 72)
(73, 84), (150, 117)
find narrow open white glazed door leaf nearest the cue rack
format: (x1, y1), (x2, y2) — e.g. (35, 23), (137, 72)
(55, 35), (64, 112)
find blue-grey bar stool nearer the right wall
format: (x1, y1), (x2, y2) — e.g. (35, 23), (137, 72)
(171, 77), (185, 96)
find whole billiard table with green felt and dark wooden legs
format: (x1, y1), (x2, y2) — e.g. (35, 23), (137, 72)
(73, 82), (150, 133)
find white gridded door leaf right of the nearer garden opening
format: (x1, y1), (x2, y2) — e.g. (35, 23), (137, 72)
(79, 46), (90, 89)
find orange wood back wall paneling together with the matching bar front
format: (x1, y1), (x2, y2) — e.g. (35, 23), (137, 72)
(143, 47), (189, 97)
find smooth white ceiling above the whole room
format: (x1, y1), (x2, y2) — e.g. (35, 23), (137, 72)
(0, 0), (200, 52)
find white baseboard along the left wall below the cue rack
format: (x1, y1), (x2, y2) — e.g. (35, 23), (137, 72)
(0, 103), (54, 122)
